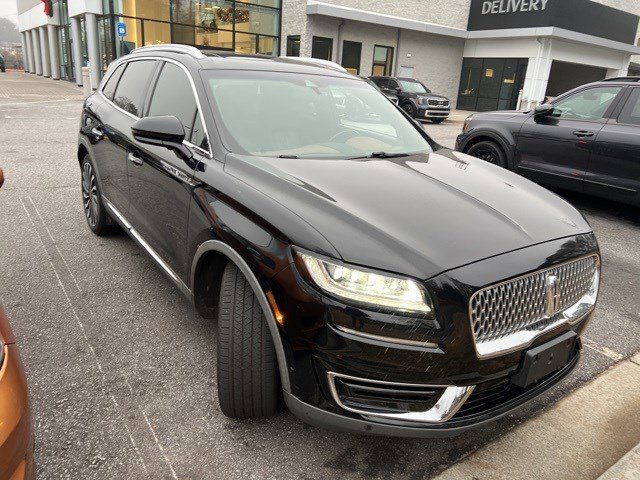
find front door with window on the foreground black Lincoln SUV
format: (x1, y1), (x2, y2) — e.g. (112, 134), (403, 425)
(128, 61), (208, 283)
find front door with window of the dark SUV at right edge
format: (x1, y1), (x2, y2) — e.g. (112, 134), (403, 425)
(516, 85), (623, 191)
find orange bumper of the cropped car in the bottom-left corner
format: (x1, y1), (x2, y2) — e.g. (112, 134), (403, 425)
(0, 345), (35, 480)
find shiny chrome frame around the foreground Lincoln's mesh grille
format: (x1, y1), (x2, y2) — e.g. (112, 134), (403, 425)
(468, 253), (601, 359)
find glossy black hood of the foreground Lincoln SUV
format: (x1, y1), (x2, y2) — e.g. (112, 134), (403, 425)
(225, 149), (591, 279)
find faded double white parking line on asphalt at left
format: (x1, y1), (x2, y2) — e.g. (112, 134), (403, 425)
(20, 197), (178, 480)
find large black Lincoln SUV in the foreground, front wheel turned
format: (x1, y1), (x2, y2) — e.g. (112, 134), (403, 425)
(78, 45), (600, 436)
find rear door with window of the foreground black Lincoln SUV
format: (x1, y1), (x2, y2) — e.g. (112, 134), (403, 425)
(97, 60), (158, 217)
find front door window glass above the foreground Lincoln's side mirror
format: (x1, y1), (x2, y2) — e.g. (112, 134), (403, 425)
(147, 62), (196, 139)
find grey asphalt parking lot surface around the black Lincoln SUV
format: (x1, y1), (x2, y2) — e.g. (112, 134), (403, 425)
(0, 73), (640, 479)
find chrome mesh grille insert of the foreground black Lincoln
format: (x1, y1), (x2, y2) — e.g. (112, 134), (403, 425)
(469, 255), (599, 344)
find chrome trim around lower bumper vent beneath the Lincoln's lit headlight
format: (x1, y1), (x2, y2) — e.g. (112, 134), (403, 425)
(327, 372), (475, 425)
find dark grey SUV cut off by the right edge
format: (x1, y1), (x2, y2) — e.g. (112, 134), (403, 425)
(456, 77), (640, 205)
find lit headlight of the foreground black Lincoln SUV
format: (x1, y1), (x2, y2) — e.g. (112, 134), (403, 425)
(297, 252), (433, 316)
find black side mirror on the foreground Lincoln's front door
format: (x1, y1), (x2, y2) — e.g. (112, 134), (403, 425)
(131, 115), (193, 160)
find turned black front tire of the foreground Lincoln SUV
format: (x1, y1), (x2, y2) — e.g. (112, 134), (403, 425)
(218, 262), (279, 418)
